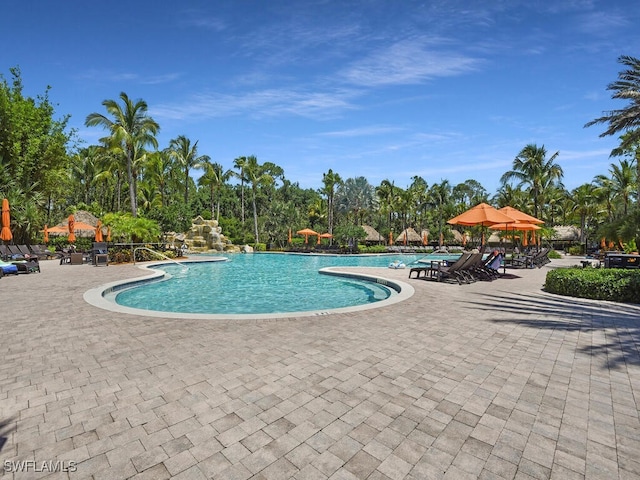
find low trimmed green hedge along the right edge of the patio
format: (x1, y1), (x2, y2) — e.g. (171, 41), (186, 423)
(544, 267), (640, 303)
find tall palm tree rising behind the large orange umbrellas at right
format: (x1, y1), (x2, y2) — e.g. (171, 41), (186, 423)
(500, 144), (563, 218)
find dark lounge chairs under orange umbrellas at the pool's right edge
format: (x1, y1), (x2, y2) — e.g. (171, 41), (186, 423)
(409, 252), (502, 285)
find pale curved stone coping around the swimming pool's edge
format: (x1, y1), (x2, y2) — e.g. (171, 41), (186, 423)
(83, 257), (415, 320)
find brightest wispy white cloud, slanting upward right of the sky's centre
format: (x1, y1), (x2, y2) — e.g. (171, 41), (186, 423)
(340, 39), (481, 87)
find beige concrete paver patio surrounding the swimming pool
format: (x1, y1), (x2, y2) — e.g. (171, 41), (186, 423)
(0, 255), (640, 480)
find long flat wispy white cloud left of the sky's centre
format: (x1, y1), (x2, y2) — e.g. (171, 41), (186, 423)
(150, 89), (357, 120)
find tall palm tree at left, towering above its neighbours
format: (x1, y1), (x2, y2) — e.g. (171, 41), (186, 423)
(85, 92), (160, 217)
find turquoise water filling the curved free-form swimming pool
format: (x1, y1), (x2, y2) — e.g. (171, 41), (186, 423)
(115, 254), (425, 314)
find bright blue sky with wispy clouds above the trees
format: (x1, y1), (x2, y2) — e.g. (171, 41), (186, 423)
(0, 0), (640, 194)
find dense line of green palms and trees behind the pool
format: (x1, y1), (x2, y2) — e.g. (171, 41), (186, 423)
(0, 56), (640, 251)
